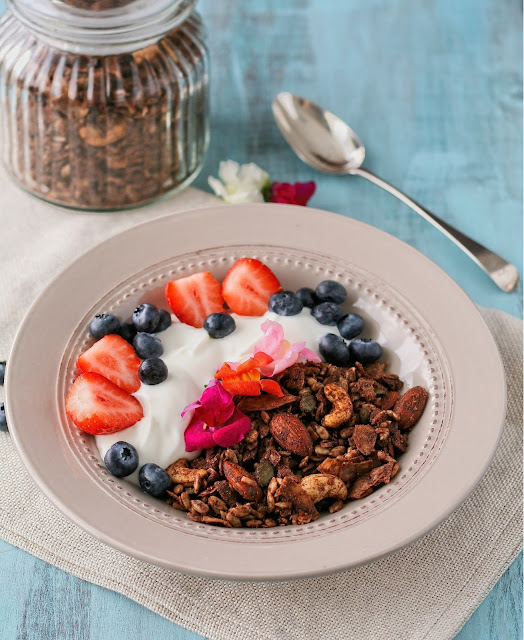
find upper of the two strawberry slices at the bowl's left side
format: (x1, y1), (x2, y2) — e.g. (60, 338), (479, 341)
(76, 334), (140, 393)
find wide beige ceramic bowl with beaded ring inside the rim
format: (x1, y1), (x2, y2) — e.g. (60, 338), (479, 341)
(6, 204), (505, 580)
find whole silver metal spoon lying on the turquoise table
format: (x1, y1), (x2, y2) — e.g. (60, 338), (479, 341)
(273, 92), (519, 292)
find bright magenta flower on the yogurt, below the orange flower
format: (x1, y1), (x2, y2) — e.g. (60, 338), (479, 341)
(182, 380), (251, 452)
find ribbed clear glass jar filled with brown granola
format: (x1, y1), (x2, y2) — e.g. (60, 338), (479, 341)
(0, 0), (209, 210)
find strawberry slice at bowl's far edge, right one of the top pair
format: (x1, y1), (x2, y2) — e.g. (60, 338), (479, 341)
(222, 258), (282, 316)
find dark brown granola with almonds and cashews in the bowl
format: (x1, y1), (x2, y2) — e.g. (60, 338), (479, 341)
(167, 362), (428, 528)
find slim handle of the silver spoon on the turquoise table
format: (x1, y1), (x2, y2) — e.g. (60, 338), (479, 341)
(351, 167), (519, 292)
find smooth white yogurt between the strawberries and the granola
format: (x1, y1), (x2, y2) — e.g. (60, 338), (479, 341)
(95, 308), (328, 484)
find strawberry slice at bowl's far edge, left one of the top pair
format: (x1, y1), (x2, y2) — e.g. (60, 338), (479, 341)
(166, 271), (224, 328)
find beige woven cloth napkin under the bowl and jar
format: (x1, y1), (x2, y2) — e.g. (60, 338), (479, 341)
(0, 176), (522, 640)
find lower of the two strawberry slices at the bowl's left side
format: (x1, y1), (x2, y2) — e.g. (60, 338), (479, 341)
(66, 373), (144, 436)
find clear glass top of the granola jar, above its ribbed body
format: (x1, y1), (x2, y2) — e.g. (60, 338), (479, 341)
(7, 0), (197, 55)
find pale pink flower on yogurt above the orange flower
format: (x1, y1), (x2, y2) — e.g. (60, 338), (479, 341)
(255, 320), (320, 377)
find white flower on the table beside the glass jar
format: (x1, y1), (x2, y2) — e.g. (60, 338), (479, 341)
(207, 160), (269, 204)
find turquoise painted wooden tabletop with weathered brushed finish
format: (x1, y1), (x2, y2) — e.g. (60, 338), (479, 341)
(0, 0), (522, 640)
